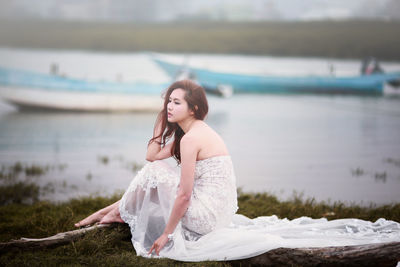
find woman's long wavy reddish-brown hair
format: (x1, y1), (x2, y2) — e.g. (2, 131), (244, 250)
(148, 80), (208, 163)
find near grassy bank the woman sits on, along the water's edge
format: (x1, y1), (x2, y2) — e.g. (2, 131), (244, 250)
(0, 193), (400, 266)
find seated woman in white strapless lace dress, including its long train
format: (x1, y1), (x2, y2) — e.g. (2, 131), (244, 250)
(75, 80), (400, 261)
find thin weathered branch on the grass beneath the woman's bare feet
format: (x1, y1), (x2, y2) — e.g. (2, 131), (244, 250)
(0, 224), (112, 253)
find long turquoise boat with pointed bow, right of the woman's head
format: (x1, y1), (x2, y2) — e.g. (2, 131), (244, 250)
(153, 58), (400, 94)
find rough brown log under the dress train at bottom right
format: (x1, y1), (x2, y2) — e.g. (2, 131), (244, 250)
(231, 242), (400, 266)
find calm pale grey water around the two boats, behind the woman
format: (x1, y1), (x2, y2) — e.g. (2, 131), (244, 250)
(0, 48), (400, 204)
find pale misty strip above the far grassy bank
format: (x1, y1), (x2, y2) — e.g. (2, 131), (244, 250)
(0, 0), (400, 23)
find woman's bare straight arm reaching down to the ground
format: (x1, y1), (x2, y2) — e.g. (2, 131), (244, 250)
(149, 136), (198, 255)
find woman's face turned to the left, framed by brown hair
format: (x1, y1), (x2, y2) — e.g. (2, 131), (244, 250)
(167, 88), (193, 123)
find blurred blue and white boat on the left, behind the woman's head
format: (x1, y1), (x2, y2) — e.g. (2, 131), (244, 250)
(0, 67), (168, 112)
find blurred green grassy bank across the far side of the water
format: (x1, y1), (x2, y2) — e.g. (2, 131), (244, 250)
(0, 21), (400, 60)
